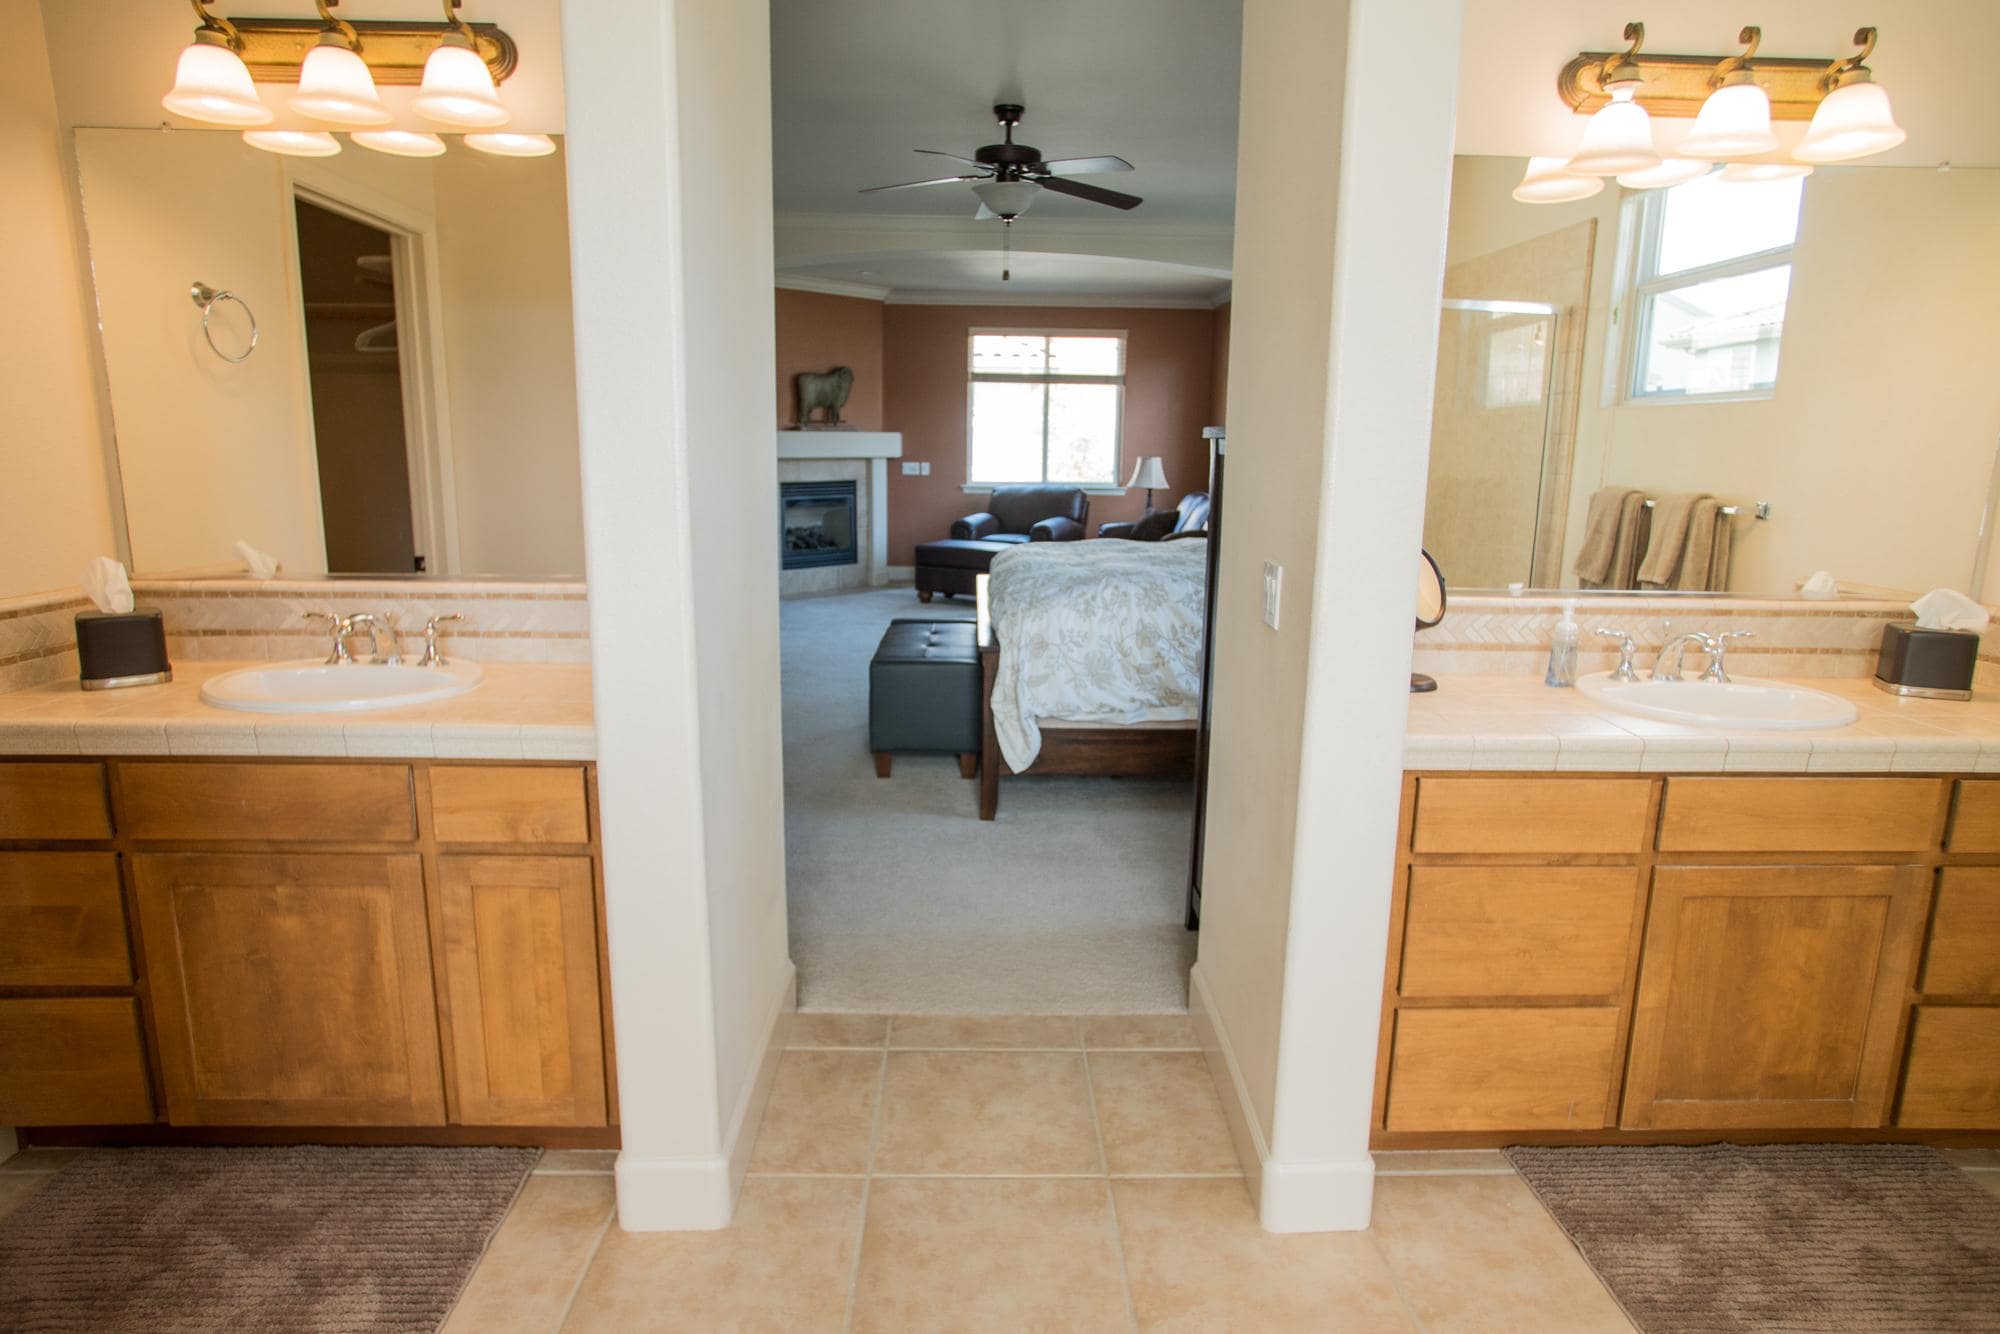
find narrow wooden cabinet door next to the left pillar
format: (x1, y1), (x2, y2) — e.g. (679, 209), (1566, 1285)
(438, 856), (606, 1126)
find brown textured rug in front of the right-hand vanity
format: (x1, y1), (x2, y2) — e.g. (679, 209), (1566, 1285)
(1506, 1144), (2000, 1334)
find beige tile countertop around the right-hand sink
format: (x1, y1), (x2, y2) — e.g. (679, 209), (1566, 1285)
(1404, 674), (2000, 774)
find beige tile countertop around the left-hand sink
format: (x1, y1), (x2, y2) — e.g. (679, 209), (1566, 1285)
(0, 662), (598, 760)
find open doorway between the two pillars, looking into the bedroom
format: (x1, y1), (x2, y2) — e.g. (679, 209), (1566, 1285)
(772, 0), (1242, 1014)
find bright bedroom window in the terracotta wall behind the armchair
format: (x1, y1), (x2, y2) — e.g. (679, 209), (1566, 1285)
(966, 330), (1124, 486)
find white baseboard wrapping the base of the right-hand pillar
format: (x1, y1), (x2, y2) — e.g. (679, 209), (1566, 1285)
(1188, 964), (1374, 1232)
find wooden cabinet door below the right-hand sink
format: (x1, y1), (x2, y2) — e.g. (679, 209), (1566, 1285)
(1620, 866), (1924, 1130)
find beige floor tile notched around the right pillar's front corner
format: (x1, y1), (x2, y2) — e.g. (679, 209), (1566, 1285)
(1112, 1182), (1416, 1332)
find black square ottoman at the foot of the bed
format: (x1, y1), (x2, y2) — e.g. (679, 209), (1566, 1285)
(868, 620), (980, 778)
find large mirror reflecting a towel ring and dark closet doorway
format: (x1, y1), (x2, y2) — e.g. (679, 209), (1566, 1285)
(76, 130), (584, 578)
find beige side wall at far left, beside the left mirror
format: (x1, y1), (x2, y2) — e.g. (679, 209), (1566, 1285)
(0, 0), (116, 598)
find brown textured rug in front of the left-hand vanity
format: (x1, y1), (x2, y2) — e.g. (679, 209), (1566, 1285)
(0, 1146), (538, 1334)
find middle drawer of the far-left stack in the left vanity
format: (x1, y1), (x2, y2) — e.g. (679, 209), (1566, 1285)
(0, 852), (132, 986)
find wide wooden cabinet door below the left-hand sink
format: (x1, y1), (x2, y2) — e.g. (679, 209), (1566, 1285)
(134, 854), (444, 1126)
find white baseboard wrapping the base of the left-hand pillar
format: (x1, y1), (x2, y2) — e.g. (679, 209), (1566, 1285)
(618, 960), (798, 1232)
